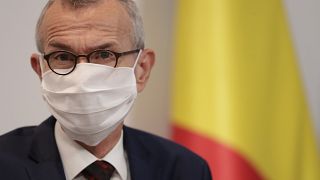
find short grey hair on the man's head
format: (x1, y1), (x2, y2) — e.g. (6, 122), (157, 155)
(35, 0), (144, 53)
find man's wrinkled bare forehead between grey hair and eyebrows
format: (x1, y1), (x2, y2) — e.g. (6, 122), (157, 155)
(40, 0), (133, 47)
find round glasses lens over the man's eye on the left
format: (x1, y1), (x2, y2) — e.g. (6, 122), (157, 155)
(49, 52), (76, 74)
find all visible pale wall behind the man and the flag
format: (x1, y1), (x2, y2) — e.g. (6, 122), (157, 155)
(0, 0), (320, 145)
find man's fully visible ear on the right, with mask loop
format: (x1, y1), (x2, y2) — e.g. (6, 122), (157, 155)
(135, 49), (155, 93)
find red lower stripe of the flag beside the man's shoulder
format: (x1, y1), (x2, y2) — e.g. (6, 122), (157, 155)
(173, 126), (264, 180)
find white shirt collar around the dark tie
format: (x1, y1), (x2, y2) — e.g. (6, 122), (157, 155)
(55, 121), (130, 180)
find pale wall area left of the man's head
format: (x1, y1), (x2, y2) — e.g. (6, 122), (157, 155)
(0, 0), (49, 130)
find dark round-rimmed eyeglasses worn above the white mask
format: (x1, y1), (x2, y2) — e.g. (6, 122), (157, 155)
(43, 49), (140, 75)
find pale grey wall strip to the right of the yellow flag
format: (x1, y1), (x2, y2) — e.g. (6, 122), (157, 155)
(285, 0), (320, 145)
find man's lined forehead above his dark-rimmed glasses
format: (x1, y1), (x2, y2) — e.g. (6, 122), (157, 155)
(40, 0), (132, 51)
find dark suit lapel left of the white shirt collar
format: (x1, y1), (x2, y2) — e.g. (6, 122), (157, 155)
(28, 117), (65, 180)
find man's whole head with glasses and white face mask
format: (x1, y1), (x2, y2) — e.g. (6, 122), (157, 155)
(31, 0), (155, 147)
